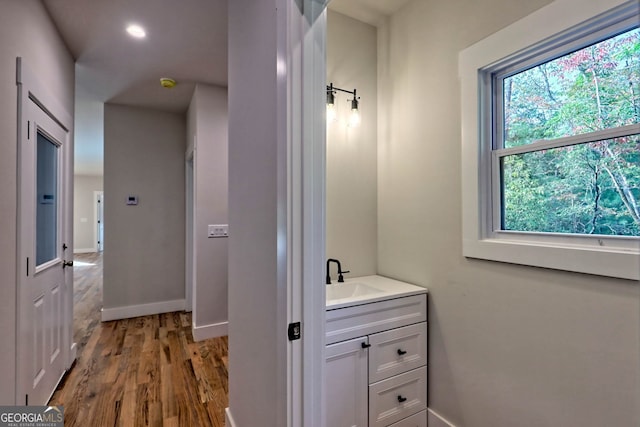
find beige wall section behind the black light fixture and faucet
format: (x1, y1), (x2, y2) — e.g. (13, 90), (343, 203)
(326, 11), (378, 279)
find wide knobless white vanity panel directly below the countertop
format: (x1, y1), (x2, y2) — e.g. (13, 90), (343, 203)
(326, 294), (427, 344)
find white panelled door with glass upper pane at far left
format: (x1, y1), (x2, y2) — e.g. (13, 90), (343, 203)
(16, 58), (73, 405)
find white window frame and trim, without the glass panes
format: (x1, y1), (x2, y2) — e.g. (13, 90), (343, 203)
(459, 0), (640, 280)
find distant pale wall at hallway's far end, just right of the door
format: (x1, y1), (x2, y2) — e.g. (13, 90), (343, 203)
(73, 175), (103, 252)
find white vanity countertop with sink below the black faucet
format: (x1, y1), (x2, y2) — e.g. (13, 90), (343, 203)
(325, 275), (428, 310)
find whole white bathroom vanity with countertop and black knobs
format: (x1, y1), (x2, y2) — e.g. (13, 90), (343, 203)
(325, 276), (427, 427)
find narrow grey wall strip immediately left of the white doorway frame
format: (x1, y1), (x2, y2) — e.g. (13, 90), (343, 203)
(229, 0), (288, 427)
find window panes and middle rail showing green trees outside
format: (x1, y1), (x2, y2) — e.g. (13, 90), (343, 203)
(492, 28), (640, 236)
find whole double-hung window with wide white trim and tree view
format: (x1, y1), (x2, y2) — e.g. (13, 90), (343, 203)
(460, 0), (640, 280)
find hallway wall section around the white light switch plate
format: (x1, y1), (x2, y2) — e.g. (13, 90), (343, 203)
(187, 84), (229, 339)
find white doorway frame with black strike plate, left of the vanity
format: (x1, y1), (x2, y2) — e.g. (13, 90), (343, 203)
(287, 0), (330, 427)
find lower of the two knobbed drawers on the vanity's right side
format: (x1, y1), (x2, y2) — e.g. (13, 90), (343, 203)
(369, 366), (427, 427)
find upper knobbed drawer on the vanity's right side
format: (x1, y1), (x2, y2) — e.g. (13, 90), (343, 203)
(369, 322), (427, 383)
